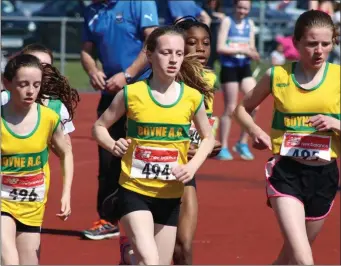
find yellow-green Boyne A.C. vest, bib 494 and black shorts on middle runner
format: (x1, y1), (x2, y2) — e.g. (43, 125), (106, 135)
(117, 80), (203, 226)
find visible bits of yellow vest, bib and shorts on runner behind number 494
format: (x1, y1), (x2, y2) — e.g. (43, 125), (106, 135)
(185, 70), (219, 188)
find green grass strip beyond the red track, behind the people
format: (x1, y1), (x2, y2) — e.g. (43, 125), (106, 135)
(55, 60), (270, 92)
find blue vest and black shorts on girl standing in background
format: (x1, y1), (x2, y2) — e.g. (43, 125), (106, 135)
(220, 17), (252, 84)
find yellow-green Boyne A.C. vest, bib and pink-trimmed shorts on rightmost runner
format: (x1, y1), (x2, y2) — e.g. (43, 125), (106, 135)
(266, 62), (340, 220)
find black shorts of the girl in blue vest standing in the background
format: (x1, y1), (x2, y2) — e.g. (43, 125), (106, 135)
(220, 64), (252, 84)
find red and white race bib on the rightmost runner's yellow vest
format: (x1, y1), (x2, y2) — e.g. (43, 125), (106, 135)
(280, 133), (331, 161)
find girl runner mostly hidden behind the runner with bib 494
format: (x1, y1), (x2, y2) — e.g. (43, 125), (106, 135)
(120, 17), (220, 265)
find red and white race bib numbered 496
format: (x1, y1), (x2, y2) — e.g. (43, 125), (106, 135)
(1, 173), (45, 202)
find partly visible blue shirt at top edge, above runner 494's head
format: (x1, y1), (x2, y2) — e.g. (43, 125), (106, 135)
(165, 0), (203, 25)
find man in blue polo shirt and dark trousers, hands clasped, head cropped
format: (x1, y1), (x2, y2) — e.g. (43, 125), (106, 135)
(81, 0), (158, 240)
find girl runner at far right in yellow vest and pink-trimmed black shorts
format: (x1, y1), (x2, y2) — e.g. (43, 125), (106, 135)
(235, 10), (340, 265)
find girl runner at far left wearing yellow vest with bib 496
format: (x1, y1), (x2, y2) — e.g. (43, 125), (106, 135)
(1, 55), (73, 265)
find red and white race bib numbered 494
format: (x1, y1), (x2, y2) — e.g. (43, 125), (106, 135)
(131, 146), (179, 180)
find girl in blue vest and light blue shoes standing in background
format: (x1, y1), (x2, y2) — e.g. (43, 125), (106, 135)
(217, 0), (259, 160)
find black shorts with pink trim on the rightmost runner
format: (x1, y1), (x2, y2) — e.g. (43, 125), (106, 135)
(265, 157), (339, 220)
